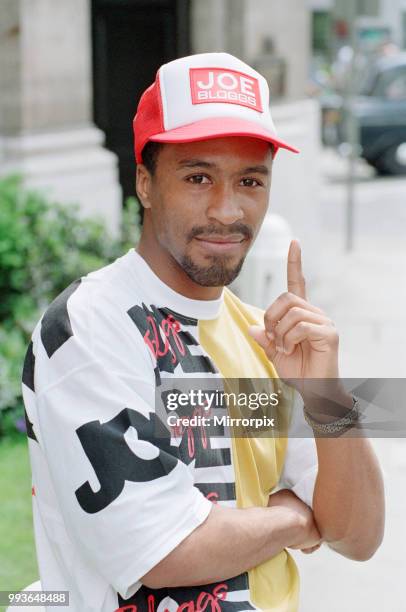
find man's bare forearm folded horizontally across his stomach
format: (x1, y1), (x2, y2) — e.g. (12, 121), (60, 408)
(141, 505), (303, 588)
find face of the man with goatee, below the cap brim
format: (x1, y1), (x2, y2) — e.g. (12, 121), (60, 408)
(137, 137), (272, 287)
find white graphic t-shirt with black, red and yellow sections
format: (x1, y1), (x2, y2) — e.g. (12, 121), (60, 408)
(23, 249), (317, 612)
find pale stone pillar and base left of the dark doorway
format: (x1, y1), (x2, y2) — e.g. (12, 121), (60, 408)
(0, 0), (121, 234)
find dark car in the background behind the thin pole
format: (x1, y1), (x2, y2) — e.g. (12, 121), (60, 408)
(320, 53), (406, 175)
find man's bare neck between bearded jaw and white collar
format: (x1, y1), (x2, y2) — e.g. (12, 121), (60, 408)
(136, 228), (223, 300)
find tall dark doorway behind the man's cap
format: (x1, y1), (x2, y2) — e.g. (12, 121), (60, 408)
(92, 0), (190, 197)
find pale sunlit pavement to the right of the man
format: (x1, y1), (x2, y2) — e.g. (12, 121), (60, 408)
(294, 151), (406, 612)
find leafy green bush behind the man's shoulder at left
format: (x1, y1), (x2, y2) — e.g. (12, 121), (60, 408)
(0, 176), (140, 436)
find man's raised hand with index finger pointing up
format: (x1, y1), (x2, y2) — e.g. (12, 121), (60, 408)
(248, 240), (338, 379)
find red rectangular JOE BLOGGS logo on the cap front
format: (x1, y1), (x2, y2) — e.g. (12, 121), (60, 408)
(190, 68), (262, 113)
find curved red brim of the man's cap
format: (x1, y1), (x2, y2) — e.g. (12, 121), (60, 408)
(149, 117), (299, 153)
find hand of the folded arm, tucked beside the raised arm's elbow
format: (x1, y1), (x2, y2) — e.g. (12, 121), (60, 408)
(268, 489), (322, 554)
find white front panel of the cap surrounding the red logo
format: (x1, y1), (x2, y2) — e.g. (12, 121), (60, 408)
(159, 53), (276, 135)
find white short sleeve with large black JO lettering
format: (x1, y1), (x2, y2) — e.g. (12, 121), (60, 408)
(30, 294), (212, 599)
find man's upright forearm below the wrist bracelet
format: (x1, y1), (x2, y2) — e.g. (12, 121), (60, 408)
(313, 434), (385, 561)
